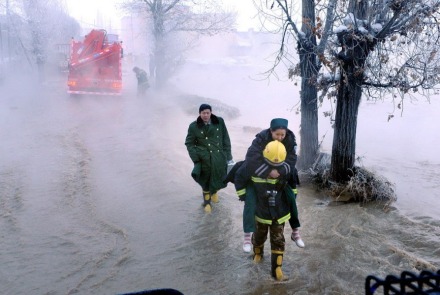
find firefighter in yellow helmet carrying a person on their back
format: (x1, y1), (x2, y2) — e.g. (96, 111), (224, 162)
(235, 140), (297, 281)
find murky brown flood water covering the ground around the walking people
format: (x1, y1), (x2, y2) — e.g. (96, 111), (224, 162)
(0, 61), (440, 294)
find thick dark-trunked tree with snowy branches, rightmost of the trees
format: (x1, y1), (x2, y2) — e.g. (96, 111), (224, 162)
(327, 0), (440, 182)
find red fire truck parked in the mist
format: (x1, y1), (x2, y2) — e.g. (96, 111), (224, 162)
(67, 30), (122, 95)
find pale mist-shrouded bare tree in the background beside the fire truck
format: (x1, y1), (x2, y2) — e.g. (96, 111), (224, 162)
(123, 0), (235, 86)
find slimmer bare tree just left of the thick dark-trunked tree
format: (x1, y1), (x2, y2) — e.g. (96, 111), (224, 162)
(254, 0), (336, 169)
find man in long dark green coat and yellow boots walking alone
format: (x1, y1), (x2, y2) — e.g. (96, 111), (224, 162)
(185, 104), (233, 213)
